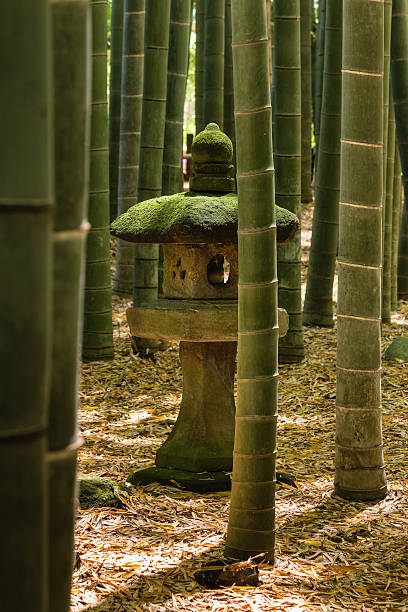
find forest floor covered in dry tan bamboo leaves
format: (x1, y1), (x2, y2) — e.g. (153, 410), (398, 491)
(72, 206), (408, 612)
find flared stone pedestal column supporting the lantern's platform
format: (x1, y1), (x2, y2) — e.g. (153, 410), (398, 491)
(156, 341), (237, 472)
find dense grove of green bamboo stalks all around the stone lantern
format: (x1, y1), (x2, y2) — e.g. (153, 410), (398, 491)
(0, 0), (408, 612)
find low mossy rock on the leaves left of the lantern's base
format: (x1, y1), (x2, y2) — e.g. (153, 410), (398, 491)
(78, 477), (130, 510)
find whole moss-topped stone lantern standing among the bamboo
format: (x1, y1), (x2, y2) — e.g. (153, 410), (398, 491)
(112, 123), (298, 490)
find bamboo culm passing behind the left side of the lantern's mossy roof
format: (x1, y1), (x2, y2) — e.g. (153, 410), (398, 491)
(133, 0), (170, 350)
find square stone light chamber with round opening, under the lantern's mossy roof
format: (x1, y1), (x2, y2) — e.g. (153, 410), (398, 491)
(163, 244), (238, 300)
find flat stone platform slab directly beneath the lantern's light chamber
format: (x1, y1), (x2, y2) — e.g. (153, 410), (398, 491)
(126, 299), (289, 342)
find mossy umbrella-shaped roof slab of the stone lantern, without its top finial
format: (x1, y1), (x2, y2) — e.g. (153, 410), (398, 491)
(111, 191), (299, 244)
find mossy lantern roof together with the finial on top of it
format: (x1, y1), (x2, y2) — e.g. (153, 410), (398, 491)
(111, 123), (299, 244)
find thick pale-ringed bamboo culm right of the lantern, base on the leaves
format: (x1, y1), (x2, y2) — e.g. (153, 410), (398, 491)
(334, 0), (387, 500)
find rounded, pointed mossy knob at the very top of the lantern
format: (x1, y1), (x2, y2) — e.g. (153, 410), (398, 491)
(191, 123), (234, 164)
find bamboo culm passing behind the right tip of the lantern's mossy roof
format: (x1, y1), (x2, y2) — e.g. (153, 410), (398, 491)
(273, 0), (304, 363)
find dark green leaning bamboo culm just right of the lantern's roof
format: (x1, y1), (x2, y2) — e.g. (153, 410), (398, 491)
(303, 0), (343, 327)
